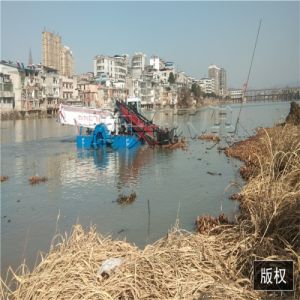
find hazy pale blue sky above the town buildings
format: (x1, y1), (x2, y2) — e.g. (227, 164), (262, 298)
(1, 1), (300, 88)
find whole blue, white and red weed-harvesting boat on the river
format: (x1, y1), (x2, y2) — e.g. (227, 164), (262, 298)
(59, 98), (176, 149)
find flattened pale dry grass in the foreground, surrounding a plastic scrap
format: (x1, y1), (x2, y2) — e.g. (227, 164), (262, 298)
(2, 225), (259, 300)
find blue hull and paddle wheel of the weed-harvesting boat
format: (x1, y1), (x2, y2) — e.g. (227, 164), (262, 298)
(76, 123), (141, 150)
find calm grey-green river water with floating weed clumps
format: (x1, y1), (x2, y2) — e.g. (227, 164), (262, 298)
(1, 102), (289, 275)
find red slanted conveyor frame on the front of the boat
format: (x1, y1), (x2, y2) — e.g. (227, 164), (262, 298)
(116, 101), (174, 146)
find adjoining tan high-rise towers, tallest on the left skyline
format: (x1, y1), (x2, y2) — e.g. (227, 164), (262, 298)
(42, 31), (74, 76)
